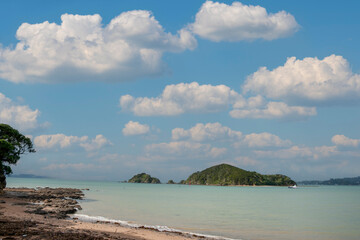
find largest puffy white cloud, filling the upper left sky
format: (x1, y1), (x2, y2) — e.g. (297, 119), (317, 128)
(0, 10), (197, 83)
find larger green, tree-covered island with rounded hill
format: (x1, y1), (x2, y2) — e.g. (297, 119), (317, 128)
(181, 164), (296, 186)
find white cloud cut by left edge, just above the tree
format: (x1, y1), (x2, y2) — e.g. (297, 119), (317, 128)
(0, 93), (47, 131)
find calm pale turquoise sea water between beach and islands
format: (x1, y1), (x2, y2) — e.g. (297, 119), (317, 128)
(8, 178), (360, 240)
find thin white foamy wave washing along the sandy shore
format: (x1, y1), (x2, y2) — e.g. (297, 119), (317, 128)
(70, 214), (235, 240)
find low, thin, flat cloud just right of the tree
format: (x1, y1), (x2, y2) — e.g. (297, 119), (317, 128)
(34, 134), (111, 151)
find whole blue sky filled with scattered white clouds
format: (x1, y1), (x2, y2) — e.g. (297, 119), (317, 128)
(0, 0), (360, 182)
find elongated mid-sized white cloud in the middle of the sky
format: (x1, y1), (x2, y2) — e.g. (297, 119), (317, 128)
(120, 82), (239, 116)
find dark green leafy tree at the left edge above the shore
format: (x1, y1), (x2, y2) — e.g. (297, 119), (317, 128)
(0, 124), (35, 190)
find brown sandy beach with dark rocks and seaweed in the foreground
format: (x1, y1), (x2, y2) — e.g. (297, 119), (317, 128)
(0, 188), (200, 240)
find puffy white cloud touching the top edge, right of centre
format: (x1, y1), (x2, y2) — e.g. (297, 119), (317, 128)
(190, 1), (299, 42)
